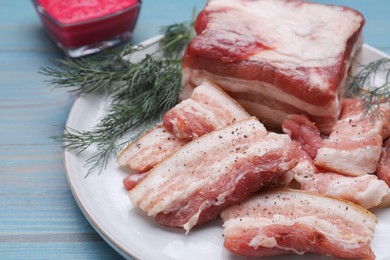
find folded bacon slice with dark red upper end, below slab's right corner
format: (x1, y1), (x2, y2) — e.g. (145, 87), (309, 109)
(283, 112), (390, 208)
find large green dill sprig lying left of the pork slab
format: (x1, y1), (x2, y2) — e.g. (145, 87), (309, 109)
(44, 19), (193, 176)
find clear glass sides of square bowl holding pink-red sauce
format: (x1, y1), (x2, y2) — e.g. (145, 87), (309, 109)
(32, 0), (141, 58)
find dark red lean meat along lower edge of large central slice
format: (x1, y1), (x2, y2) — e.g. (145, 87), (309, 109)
(156, 151), (291, 226)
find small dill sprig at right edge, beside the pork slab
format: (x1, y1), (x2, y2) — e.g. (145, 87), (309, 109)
(345, 58), (390, 116)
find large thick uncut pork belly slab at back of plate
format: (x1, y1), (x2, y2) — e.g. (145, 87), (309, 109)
(182, 0), (364, 133)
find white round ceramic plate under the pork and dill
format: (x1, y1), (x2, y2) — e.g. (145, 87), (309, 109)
(65, 38), (390, 260)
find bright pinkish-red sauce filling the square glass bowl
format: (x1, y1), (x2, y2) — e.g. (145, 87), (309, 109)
(35, 0), (141, 51)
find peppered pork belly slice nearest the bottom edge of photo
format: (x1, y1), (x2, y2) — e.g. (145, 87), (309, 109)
(221, 189), (376, 259)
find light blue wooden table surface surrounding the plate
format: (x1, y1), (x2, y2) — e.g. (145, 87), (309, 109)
(0, 0), (390, 259)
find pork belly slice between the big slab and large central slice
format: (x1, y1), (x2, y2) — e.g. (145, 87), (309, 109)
(163, 81), (249, 141)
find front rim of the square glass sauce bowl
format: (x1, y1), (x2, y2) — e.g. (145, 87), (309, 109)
(31, 0), (142, 27)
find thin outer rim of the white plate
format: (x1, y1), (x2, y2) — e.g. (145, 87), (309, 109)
(63, 41), (390, 259)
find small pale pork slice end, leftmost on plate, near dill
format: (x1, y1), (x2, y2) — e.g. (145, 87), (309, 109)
(117, 126), (186, 173)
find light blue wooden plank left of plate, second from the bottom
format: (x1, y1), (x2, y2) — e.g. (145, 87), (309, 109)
(0, 145), (93, 234)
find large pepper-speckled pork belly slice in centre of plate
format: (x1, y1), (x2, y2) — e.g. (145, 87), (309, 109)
(129, 118), (296, 232)
